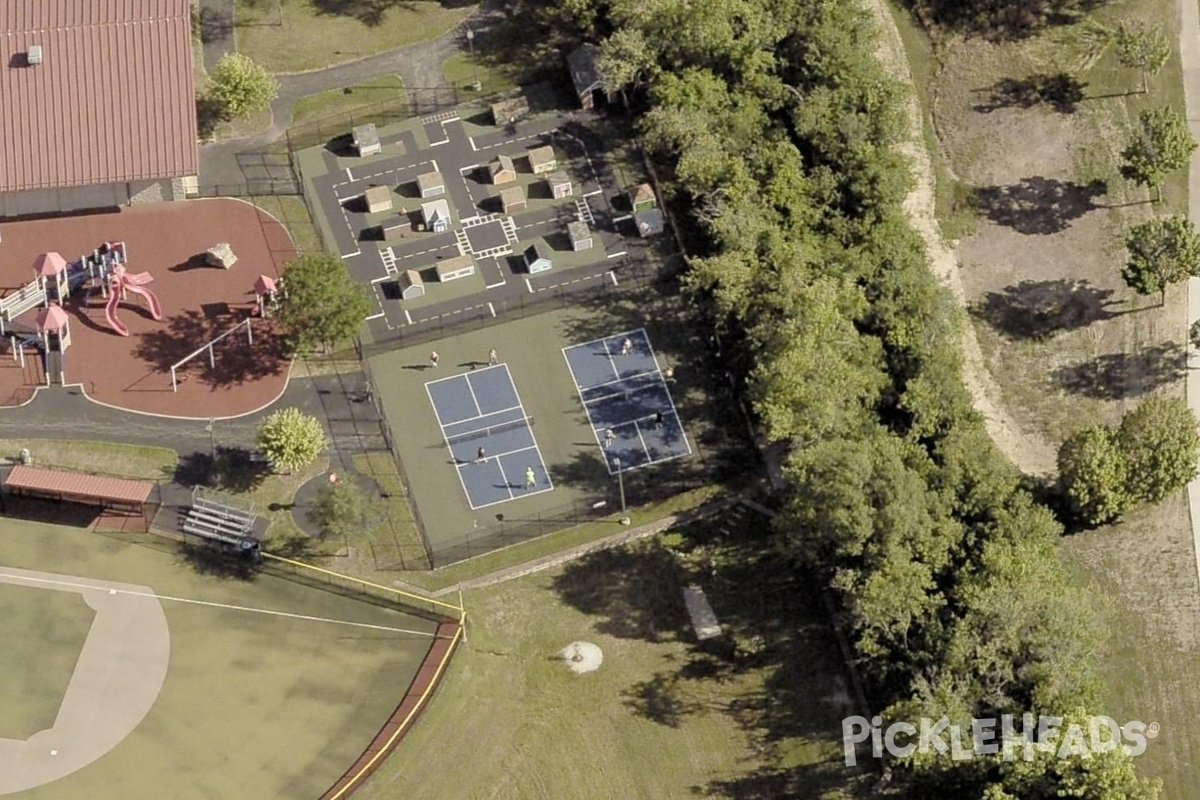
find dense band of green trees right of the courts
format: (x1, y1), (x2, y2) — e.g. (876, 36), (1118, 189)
(560, 0), (1180, 800)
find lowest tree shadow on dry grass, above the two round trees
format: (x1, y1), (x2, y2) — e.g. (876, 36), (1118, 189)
(1051, 342), (1188, 399)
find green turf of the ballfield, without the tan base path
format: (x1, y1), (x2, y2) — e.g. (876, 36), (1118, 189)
(0, 519), (436, 800)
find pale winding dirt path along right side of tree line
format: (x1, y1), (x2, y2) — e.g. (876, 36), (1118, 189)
(866, 0), (1056, 476)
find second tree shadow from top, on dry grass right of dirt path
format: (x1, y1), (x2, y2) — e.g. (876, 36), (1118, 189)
(974, 175), (1108, 236)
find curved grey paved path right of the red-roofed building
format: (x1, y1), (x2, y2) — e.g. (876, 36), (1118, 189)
(200, 0), (498, 187)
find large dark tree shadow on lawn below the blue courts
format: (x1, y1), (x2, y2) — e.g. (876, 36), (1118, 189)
(553, 506), (870, 800)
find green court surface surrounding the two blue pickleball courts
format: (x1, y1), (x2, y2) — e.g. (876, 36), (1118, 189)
(370, 293), (712, 564)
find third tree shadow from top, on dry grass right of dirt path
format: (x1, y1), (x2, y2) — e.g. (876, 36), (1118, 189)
(970, 278), (1130, 342)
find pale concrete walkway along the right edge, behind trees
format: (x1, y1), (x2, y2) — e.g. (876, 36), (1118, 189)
(1180, 0), (1200, 587)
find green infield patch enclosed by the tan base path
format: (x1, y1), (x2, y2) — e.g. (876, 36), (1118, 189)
(0, 584), (96, 739)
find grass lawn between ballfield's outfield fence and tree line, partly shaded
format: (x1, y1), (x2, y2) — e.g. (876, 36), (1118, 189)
(356, 510), (870, 800)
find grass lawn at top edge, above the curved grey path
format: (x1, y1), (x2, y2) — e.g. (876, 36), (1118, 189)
(234, 0), (475, 72)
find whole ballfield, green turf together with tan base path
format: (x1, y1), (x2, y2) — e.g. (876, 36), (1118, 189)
(0, 519), (437, 800)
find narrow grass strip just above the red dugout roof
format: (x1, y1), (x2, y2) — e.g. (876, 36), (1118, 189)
(0, 439), (179, 481)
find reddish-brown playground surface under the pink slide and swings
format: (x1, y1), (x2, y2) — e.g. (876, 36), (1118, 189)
(0, 198), (295, 419)
